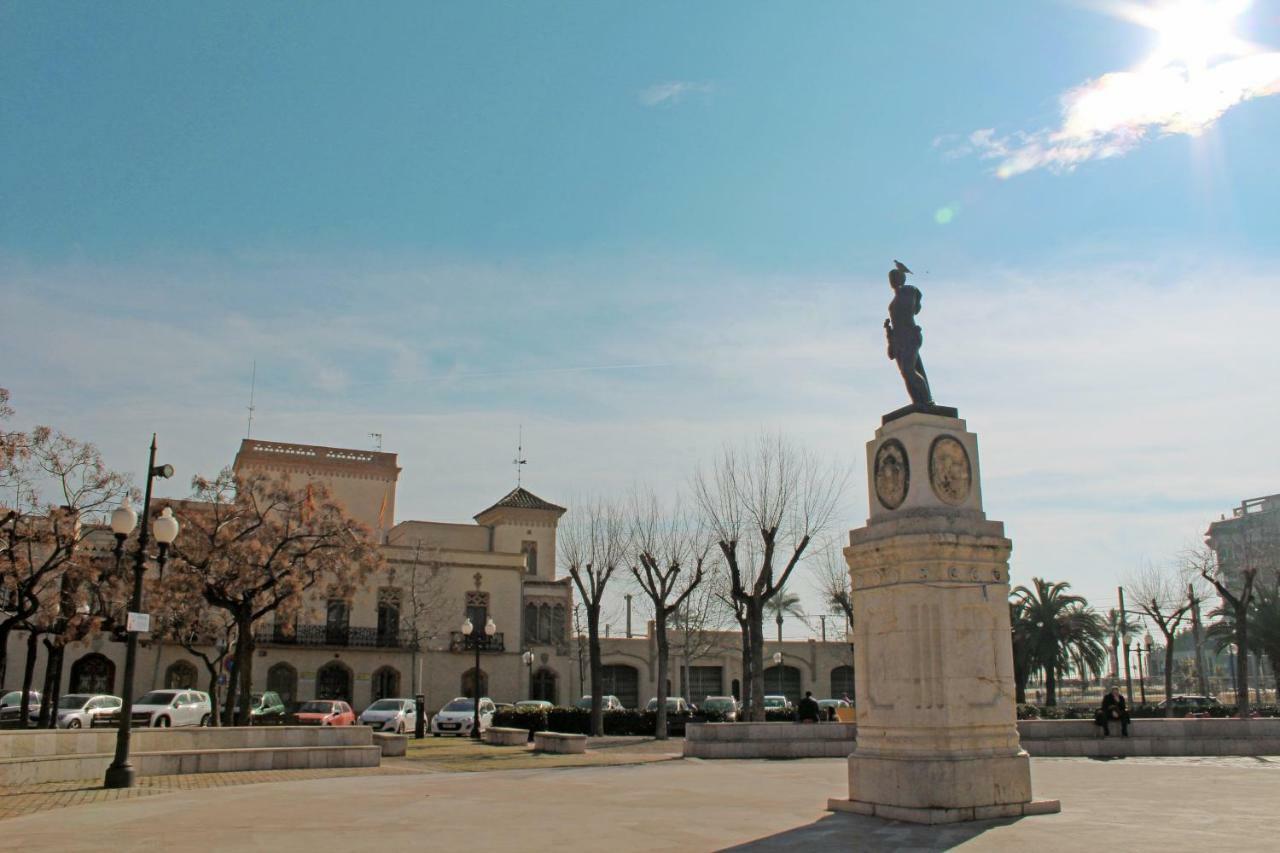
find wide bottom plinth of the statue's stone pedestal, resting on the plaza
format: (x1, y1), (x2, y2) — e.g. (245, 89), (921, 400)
(828, 751), (1060, 824)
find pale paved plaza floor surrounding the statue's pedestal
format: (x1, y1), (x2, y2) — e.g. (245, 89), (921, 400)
(0, 758), (1280, 853)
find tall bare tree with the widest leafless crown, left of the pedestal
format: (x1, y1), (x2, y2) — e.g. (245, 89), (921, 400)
(694, 435), (847, 721)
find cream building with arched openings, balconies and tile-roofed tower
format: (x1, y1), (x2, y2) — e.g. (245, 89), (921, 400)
(3, 439), (852, 710)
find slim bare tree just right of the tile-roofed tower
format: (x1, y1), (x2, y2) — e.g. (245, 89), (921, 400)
(558, 500), (627, 736)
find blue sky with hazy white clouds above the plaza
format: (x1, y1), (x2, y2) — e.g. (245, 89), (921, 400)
(0, 0), (1280, 635)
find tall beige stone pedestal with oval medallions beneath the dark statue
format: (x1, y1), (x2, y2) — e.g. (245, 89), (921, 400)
(829, 411), (1059, 824)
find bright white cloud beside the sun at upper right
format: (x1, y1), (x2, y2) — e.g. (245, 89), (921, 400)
(962, 6), (1280, 178)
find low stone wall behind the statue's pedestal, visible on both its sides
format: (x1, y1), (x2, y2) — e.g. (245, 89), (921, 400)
(685, 719), (1280, 758)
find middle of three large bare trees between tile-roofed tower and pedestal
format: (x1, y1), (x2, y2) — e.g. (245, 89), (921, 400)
(628, 492), (710, 740)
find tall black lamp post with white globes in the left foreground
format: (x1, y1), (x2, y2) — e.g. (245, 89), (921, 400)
(102, 433), (178, 788)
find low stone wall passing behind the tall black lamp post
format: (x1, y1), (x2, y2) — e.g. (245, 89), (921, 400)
(0, 726), (381, 785)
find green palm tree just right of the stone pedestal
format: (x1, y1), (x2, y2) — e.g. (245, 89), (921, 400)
(1014, 578), (1106, 704)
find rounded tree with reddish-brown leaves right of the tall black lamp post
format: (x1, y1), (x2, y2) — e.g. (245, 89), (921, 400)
(170, 470), (381, 722)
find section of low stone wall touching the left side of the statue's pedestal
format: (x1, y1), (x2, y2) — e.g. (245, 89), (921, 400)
(685, 722), (858, 758)
